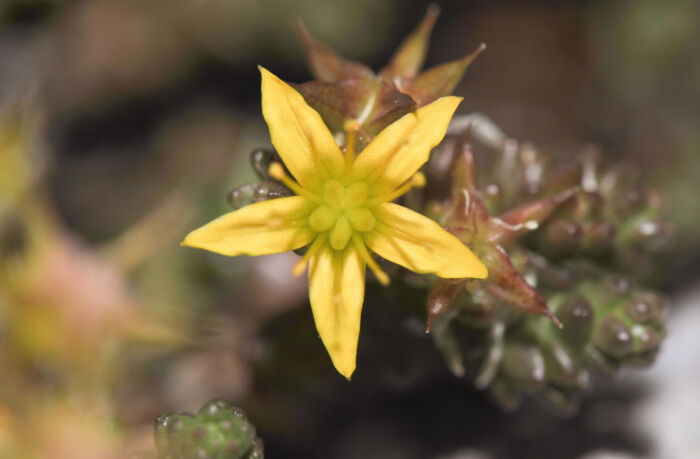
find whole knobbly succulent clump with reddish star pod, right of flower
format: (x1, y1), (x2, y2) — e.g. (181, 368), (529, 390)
(425, 115), (671, 412)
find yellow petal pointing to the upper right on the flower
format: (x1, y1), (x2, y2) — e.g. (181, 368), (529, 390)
(353, 96), (462, 196)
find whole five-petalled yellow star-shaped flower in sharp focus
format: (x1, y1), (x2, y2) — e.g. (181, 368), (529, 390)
(183, 67), (487, 379)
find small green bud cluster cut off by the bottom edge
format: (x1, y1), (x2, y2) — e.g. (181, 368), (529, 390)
(155, 399), (263, 459)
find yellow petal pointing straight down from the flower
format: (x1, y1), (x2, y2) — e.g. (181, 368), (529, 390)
(309, 247), (365, 379)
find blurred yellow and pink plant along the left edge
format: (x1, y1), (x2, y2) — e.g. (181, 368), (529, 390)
(0, 118), (191, 458)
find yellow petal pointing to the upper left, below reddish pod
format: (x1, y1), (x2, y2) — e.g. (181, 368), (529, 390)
(260, 67), (344, 191)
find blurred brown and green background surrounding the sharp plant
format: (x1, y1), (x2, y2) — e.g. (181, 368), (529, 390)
(0, 0), (700, 459)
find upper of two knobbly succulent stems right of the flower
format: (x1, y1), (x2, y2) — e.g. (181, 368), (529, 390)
(433, 122), (672, 278)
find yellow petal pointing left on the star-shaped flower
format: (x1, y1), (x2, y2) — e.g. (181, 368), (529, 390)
(182, 196), (316, 256)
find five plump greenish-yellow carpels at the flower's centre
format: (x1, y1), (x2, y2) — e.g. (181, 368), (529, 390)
(309, 180), (377, 250)
